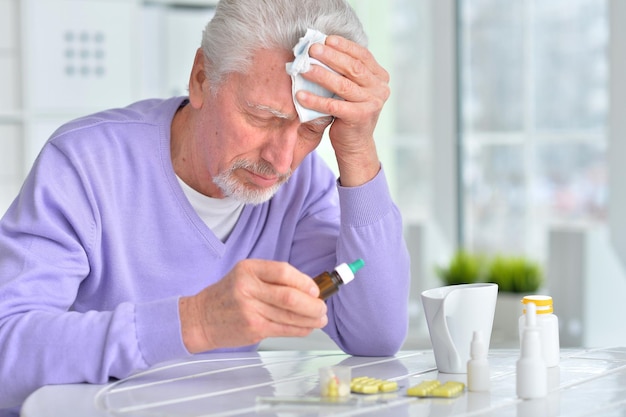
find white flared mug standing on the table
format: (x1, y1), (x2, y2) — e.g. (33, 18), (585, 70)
(421, 283), (498, 374)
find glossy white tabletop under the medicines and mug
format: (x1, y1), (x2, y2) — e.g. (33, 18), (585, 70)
(21, 347), (626, 417)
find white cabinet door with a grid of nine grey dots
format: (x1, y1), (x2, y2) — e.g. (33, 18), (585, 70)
(22, 0), (139, 116)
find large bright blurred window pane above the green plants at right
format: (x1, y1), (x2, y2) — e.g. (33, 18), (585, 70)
(458, 0), (609, 259)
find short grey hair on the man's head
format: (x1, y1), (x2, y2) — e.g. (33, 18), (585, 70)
(202, 0), (367, 93)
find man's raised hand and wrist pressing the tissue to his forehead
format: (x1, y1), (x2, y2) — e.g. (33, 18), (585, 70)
(288, 32), (390, 186)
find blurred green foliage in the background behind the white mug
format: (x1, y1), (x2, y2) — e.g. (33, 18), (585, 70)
(435, 250), (543, 293)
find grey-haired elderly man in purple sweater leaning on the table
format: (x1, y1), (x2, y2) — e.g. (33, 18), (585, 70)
(0, 0), (409, 408)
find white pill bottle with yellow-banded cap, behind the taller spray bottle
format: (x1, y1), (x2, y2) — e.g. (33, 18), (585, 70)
(519, 295), (561, 368)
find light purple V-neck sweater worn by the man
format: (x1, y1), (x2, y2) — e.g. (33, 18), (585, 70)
(0, 98), (409, 408)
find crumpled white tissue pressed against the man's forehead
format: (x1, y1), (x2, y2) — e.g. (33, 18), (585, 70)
(286, 29), (334, 123)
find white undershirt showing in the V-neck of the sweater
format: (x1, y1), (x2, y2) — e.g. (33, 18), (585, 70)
(176, 176), (244, 242)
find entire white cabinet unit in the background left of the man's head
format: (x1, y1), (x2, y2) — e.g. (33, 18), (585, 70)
(0, 0), (217, 216)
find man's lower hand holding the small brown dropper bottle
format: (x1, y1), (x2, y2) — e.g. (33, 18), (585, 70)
(179, 260), (328, 353)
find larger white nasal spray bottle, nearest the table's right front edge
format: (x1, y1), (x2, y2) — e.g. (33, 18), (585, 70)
(516, 303), (548, 399)
